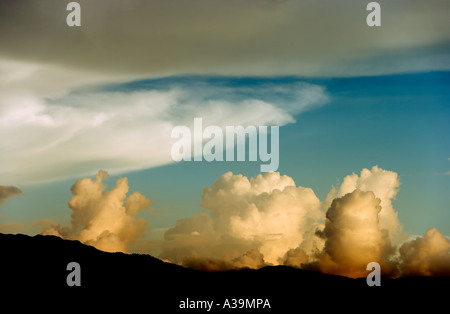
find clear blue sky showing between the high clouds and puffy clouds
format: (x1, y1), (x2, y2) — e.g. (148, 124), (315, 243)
(0, 72), (450, 240)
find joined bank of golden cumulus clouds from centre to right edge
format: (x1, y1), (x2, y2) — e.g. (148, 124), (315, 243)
(160, 166), (450, 278)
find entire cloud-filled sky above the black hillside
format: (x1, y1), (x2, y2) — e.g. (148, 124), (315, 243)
(0, 0), (450, 276)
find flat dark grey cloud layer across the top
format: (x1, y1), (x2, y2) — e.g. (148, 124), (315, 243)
(0, 0), (450, 77)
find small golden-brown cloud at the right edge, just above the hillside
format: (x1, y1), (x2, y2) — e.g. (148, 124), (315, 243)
(400, 228), (450, 276)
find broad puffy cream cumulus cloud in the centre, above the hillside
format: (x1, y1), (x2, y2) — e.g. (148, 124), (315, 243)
(160, 172), (322, 269)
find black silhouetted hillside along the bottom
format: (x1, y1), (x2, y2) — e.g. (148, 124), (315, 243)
(0, 234), (450, 313)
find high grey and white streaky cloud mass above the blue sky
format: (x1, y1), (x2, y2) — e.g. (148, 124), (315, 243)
(0, 0), (450, 184)
